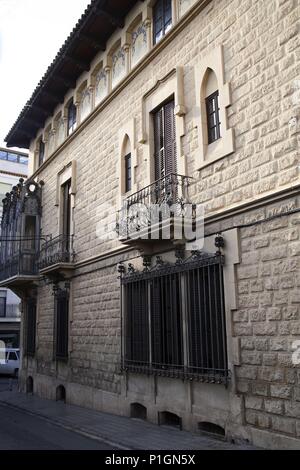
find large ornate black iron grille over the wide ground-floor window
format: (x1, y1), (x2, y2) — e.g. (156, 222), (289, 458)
(121, 252), (229, 384)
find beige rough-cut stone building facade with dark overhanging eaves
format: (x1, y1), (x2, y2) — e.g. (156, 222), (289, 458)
(5, 0), (300, 448)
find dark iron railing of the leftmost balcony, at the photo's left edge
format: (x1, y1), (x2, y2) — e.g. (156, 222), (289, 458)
(0, 252), (38, 281)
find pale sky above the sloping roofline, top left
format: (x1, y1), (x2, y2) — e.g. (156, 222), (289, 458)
(0, 0), (90, 151)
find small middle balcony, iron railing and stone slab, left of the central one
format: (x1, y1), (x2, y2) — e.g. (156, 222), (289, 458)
(37, 235), (75, 277)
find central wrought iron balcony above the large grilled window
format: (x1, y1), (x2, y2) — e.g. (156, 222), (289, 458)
(116, 173), (193, 243)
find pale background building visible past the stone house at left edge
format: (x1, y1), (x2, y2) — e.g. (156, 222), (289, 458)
(0, 147), (28, 347)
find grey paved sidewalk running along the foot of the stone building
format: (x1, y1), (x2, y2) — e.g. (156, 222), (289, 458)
(0, 390), (253, 450)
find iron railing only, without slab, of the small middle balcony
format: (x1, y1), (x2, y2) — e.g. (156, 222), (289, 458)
(38, 235), (75, 270)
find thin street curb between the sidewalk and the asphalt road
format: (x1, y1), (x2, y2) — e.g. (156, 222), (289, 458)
(0, 400), (131, 450)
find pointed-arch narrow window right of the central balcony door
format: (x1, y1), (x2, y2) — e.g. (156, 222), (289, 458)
(204, 69), (221, 145)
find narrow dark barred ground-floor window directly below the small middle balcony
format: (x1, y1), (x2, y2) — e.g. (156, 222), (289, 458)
(55, 290), (69, 359)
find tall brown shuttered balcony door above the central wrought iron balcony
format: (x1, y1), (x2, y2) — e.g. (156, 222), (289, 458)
(153, 100), (177, 180)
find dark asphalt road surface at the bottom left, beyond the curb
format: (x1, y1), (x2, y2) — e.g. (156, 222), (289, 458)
(0, 377), (113, 450)
